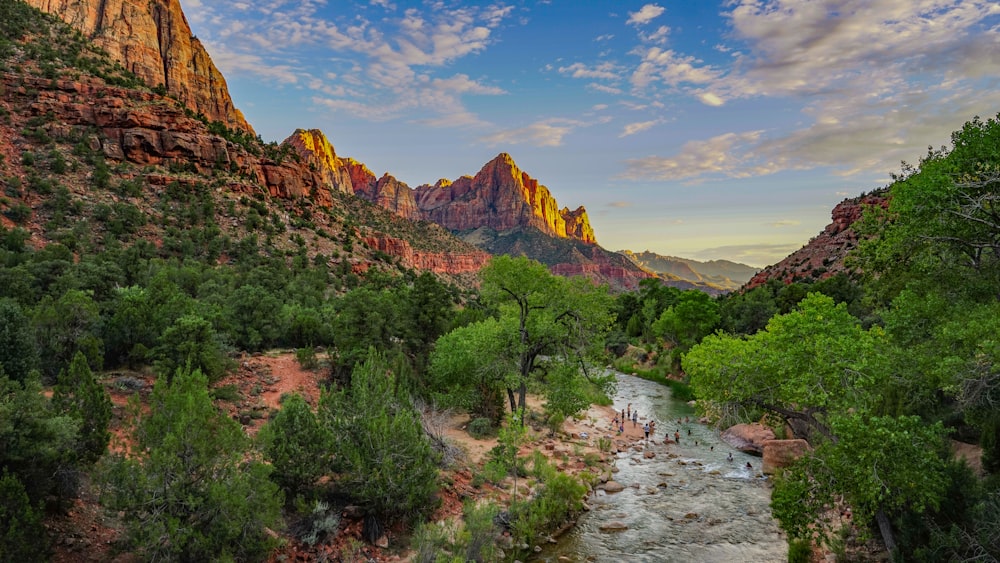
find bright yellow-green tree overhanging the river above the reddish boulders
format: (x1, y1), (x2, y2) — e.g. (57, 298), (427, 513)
(683, 293), (885, 438)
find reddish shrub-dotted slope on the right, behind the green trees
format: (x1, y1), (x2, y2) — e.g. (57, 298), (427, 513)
(744, 192), (889, 289)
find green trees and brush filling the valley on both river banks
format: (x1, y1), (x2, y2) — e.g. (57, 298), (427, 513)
(0, 0), (1000, 561)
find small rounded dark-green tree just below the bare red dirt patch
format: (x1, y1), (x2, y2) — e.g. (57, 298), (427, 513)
(257, 393), (334, 495)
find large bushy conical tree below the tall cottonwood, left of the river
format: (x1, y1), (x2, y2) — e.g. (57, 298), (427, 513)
(320, 349), (438, 539)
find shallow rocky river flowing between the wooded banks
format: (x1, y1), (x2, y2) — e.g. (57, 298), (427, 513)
(532, 374), (788, 563)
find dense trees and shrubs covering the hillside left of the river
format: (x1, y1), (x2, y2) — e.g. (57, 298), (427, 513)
(0, 0), (607, 561)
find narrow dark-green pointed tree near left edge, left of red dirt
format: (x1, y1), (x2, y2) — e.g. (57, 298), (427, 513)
(52, 352), (111, 464)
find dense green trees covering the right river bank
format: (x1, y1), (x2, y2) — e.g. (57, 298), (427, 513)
(683, 115), (1000, 561)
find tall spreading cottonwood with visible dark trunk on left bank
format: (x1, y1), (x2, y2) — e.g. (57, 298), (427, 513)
(431, 256), (613, 418)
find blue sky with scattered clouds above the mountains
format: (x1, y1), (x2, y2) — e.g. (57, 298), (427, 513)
(180, 0), (1000, 267)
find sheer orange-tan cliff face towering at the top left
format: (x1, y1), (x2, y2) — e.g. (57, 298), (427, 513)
(26, 0), (253, 133)
